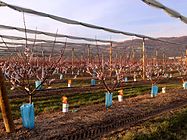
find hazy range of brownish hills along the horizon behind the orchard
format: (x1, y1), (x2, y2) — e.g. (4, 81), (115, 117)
(5, 36), (187, 58)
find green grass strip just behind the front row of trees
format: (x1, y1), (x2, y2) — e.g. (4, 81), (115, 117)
(0, 79), (180, 118)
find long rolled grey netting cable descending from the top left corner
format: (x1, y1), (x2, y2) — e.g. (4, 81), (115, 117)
(0, 1), (185, 45)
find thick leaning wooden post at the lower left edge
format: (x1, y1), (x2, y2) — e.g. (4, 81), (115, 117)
(0, 68), (14, 133)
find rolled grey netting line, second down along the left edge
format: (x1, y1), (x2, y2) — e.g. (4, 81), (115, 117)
(0, 25), (118, 43)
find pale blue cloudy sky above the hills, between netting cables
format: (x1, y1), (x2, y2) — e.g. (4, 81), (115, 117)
(0, 0), (187, 41)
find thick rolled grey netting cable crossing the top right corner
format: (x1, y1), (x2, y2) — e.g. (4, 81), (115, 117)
(142, 0), (187, 24)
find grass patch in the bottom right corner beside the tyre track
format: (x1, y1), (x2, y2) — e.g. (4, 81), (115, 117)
(108, 107), (187, 140)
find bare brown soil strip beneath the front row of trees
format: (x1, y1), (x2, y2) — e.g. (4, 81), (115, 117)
(0, 89), (187, 140)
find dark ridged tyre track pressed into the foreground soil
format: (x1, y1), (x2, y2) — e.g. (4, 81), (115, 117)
(59, 101), (187, 140)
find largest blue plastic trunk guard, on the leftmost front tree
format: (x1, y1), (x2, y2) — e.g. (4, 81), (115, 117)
(20, 104), (34, 129)
